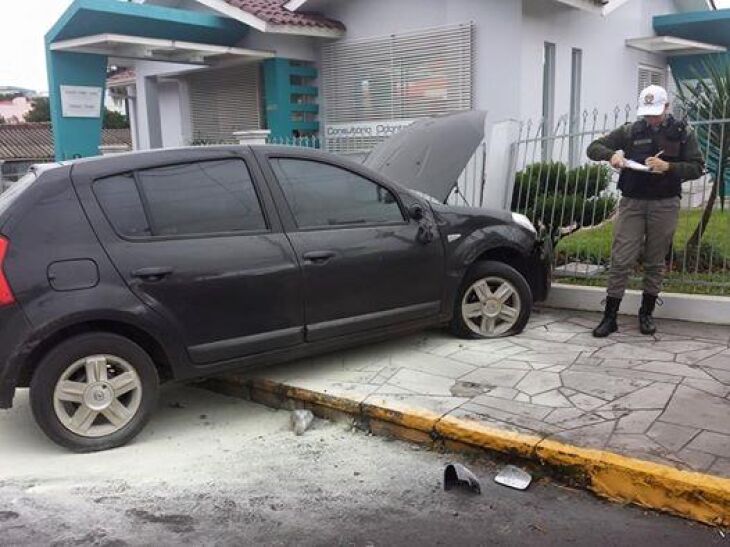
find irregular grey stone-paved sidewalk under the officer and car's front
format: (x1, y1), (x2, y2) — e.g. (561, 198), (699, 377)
(242, 309), (730, 477)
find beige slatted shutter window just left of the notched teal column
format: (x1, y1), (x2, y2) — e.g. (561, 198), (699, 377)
(187, 64), (261, 144)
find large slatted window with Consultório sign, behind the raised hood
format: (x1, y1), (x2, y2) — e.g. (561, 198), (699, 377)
(320, 23), (474, 152)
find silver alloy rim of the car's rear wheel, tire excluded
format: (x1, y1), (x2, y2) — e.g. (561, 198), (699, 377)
(53, 355), (142, 438)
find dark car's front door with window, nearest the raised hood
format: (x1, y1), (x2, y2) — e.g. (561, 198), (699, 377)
(258, 155), (444, 341)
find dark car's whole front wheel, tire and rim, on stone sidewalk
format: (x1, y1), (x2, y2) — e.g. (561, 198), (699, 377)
(451, 261), (532, 338)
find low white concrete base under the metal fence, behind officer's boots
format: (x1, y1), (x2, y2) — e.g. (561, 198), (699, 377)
(543, 283), (730, 325)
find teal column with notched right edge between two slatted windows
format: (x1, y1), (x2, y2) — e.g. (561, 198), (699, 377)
(264, 57), (319, 138)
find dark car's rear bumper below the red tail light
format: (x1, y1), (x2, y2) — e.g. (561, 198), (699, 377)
(0, 305), (30, 408)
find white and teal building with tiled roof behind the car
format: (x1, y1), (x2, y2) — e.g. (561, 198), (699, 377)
(47, 0), (726, 159)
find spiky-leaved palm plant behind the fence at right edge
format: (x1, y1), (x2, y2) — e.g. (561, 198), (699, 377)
(679, 60), (730, 248)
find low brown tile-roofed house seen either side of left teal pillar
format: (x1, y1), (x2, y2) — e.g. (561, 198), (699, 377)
(0, 123), (132, 186)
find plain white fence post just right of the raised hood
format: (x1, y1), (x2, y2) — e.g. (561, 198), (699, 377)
(480, 120), (520, 210)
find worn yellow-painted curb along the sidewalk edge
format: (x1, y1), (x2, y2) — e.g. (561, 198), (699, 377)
(200, 375), (730, 526)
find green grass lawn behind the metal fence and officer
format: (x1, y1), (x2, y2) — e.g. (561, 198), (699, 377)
(556, 210), (730, 296)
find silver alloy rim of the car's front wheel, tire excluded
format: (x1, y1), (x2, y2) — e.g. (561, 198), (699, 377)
(461, 276), (522, 338)
